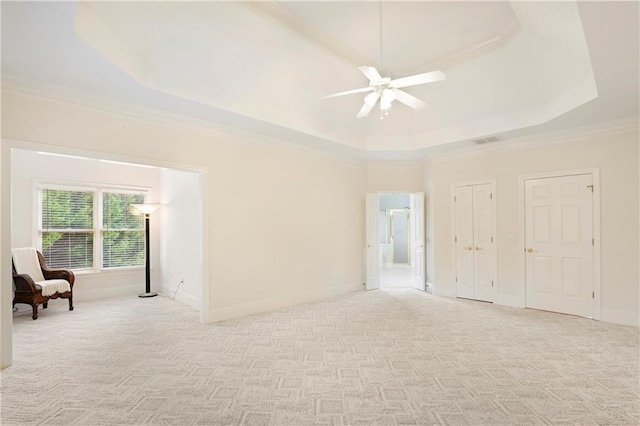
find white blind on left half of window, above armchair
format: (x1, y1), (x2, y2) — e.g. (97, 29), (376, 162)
(40, 189), (94, 269)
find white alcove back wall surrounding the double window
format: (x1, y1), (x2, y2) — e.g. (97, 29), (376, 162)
(11, 149), (160, 301)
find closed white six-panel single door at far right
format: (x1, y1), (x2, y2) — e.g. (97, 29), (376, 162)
(525, 174), (594, 317)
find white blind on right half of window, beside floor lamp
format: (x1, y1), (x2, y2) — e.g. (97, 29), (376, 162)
(102, 191), (145, 268)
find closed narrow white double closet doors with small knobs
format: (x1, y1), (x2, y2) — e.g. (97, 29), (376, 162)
(454, 184), (494, 302)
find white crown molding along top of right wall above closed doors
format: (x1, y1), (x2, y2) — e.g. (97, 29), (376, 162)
(426, 117), (640, 163)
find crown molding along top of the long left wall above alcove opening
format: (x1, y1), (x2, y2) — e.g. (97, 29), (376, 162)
(1, 75), (365, 167)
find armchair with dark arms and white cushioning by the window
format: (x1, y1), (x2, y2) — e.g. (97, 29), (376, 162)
(11, 247), (75, 320)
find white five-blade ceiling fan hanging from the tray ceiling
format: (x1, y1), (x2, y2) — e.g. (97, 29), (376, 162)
(322, 66), (445, 119)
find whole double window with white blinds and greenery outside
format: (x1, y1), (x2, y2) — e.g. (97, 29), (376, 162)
(39, 187), (147, 269)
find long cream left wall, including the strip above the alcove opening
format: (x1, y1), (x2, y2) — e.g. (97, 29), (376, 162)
(2, 93), (366, 332)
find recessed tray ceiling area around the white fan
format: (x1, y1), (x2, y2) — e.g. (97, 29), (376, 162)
(70, 2), (597, 151)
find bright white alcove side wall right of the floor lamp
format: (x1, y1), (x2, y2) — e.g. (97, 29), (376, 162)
(159, 168), (203, 310)
